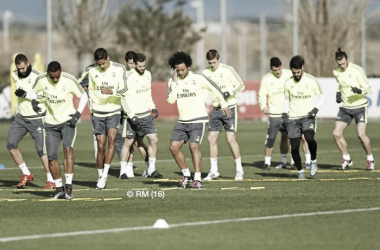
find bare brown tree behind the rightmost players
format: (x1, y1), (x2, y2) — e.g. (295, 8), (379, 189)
(286, 0), (369, 76)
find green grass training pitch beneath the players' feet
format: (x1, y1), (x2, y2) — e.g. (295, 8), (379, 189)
(0, 120), (380, 250)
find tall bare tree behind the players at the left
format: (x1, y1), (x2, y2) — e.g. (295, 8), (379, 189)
(54, 0), (112, 74)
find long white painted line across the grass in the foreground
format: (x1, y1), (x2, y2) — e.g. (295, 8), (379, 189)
(0, 207), (380, 242)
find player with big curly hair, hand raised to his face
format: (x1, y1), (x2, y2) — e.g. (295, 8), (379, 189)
(166, 51), (231, 188)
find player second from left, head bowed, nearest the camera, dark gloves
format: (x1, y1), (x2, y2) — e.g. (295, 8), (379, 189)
(30, 61), (88, 200)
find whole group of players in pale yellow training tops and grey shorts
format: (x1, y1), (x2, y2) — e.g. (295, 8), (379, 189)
(7, 48), (375, 199)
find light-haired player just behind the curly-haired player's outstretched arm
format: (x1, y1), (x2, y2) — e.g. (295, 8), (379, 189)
(202, 49), (245, 181)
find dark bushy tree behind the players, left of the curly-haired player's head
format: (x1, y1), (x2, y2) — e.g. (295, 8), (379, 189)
(117, 0), (205, 80)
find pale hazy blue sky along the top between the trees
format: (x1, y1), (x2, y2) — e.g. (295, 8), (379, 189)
(0, 0), (284, 22)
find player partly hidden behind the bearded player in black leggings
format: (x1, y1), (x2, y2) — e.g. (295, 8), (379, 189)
(258, 57), (310, 170)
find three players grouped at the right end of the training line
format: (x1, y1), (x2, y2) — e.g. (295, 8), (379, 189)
(258, 48), (375, 179)
